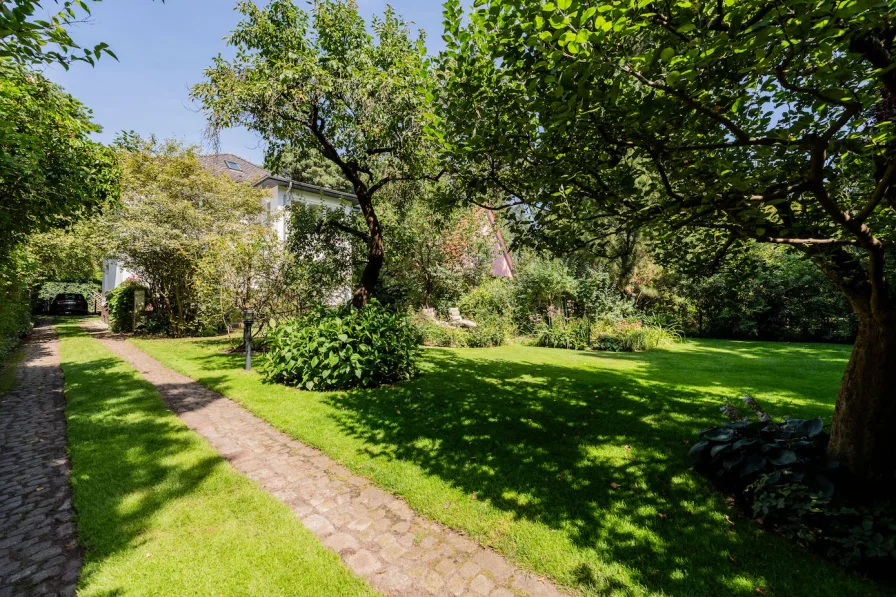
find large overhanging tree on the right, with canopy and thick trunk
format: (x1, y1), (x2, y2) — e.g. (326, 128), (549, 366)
(435, 0), (896, 481)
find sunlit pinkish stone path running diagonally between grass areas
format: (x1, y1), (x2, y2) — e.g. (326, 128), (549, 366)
(84, 320), (563, 597)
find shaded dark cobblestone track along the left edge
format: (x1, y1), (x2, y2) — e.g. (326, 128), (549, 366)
(0, 322), (81, 597)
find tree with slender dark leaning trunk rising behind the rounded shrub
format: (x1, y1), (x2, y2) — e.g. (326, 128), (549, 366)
(193, 0), (438, 307)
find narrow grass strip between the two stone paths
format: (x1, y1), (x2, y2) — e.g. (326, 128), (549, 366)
(57, 321), (376, 597)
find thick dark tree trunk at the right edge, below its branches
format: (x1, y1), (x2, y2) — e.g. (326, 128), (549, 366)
(828, 306), (896, 488)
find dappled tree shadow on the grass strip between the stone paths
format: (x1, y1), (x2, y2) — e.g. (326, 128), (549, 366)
(63, 354), (224, 595)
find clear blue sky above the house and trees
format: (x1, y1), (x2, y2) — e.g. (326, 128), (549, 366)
(46, 0), (452, 163)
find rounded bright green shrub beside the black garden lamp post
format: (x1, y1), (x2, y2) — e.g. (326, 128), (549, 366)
(262, 300), (420, 390)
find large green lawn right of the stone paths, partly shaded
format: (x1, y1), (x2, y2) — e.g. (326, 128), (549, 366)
(133, 339), (878, 596)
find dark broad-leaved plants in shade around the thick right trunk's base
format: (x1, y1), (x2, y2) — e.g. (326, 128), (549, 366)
(690, 396), (896, 570)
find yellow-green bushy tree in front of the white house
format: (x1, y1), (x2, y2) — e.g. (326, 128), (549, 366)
(102, 139), (269, 336)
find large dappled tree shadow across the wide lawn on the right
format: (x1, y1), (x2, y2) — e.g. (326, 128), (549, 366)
(326, 349), (875, 595)
